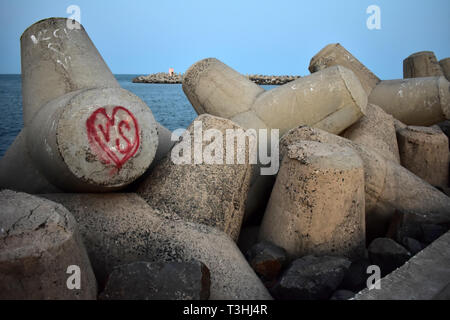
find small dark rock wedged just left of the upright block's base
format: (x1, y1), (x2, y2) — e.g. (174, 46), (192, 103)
(247, 241), (286, 280)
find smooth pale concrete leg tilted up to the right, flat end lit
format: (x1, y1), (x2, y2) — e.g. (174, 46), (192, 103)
(254, 66), (367, 135)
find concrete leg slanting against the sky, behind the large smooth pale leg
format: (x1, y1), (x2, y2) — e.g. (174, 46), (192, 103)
(309, 43), (380, 95)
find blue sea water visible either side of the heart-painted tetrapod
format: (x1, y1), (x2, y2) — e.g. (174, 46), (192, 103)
(0, 74), (274, 157)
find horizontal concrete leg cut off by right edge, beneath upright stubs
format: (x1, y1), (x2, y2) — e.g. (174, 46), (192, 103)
(369, 77), (450, 126)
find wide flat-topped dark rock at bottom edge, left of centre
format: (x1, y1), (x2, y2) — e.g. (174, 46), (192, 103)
(99, 261), (210, 300)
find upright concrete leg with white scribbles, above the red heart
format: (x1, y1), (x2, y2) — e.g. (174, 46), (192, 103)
(20, 18), (119, 126)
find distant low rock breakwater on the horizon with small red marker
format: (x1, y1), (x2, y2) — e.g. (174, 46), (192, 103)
(132, 72), (300, 85)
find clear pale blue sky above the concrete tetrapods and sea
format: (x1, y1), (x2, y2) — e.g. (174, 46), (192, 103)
(0, 0), (450, 79)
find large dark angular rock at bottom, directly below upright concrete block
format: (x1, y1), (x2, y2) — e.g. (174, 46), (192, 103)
(272, 256), (351, 300)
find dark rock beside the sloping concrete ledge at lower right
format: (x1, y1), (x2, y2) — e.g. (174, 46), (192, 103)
(368, 238), (411, 276)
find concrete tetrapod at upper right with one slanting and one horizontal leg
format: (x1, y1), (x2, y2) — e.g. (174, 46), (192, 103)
(309, 44), (450, 127)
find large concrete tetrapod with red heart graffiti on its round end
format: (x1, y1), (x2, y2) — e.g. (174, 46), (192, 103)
(0, 18), (158, 192)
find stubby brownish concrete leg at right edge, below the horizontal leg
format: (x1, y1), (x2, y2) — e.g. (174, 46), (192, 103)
(397, 126), (449, 187)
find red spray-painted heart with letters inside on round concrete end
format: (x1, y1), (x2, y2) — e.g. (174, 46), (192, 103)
(86, 106), (140, 170)
